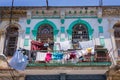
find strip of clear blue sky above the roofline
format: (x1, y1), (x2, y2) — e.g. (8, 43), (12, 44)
(0, 0), (120, 6)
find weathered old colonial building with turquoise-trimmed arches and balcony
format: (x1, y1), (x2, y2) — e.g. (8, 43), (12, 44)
(0, 2), (120, 80)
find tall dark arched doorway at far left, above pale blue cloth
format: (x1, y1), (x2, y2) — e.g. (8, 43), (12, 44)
(3, 26), (19, 56)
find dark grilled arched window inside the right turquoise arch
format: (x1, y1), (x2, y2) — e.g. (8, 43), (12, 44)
(72, 24), (89, 43)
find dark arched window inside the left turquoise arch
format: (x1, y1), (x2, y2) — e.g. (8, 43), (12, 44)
(37, 24), (54, 43)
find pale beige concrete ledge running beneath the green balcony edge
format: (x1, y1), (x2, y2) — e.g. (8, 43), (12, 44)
(24, 69), (107, 75)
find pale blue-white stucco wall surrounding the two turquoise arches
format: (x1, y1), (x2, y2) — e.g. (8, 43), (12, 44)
(0, 18), (117, 53)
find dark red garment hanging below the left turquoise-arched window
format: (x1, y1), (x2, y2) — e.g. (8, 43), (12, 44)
(31, 41), (47, 50)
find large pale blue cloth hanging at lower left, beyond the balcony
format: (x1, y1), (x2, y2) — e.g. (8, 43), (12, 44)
(9, 50), (28, 70)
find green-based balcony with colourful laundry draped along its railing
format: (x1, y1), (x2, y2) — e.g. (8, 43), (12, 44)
(27, 46), (112, 67)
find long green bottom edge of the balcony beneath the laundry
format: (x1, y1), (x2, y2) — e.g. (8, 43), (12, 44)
(27, 62), (111, 67)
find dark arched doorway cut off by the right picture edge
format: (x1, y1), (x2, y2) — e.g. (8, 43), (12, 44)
(113, 22), (120, 57)
